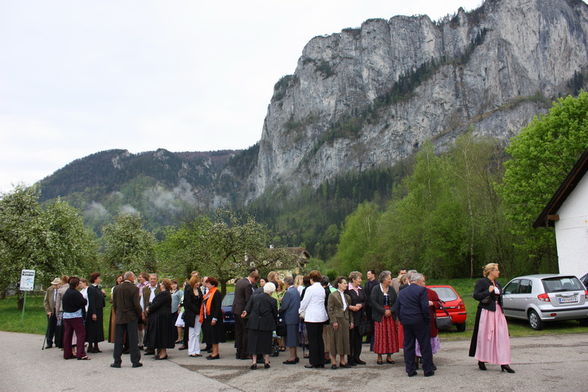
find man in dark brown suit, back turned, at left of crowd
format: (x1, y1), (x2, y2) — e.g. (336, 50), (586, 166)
(110, 271), (143, 368)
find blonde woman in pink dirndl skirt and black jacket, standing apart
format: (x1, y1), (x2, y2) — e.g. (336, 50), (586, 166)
(469, 263), (515, 373)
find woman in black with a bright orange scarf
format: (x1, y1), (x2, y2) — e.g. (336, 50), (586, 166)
(200, 276), (225, 359)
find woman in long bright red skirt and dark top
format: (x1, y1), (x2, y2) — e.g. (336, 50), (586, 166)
(370, 271), (399, 365)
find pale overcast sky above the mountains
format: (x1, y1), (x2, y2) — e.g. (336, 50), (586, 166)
(0, 0), (482, 193)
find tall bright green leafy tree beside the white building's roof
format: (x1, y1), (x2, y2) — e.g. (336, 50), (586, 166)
(499, 92), (588, 272)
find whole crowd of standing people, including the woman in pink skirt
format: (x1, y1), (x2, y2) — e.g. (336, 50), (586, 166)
(44, 264), (514, 377)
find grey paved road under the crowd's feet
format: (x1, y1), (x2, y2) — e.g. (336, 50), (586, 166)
(0, 332), (588, 392)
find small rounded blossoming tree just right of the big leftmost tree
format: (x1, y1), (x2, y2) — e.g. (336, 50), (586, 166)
(102, 214), (157, 273)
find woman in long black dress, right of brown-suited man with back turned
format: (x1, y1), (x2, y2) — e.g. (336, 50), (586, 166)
(147, 279), (174, 359)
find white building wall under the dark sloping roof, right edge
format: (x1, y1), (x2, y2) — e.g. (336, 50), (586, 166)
(555, 174), (588, 277)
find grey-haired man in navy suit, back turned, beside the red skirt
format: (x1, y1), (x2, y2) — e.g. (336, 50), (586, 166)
(393, 272), (435, 377)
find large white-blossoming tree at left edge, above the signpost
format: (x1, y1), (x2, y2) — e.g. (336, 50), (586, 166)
(0, 186), (96, 306)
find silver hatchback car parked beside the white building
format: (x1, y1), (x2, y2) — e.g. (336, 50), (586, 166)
(502, 274), (588, 329)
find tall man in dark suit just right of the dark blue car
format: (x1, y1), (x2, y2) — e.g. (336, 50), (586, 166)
(232, 268), (259, 359)
